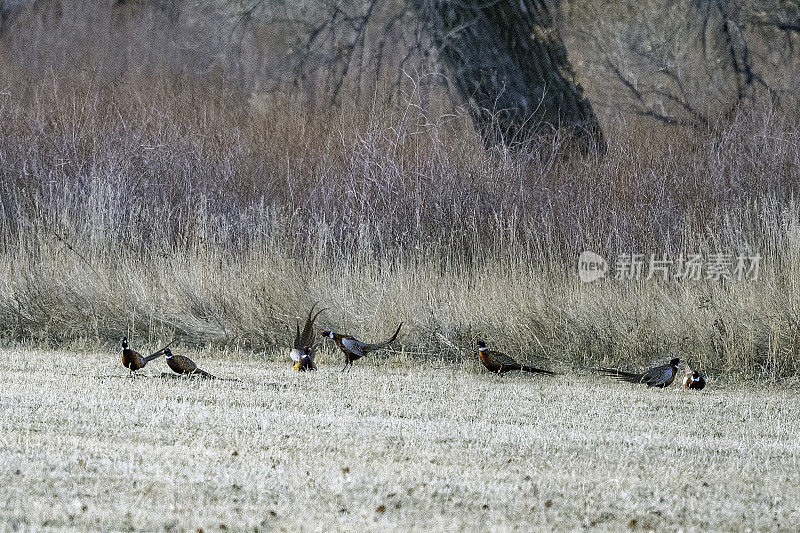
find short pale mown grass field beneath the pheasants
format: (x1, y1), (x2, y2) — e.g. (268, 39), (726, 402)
(0, 350), (800, 531)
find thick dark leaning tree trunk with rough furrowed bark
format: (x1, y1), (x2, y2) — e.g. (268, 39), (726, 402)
(411, 0), (605, 151)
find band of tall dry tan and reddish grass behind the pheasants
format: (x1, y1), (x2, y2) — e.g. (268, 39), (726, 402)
(0, 62), (800, 378)
